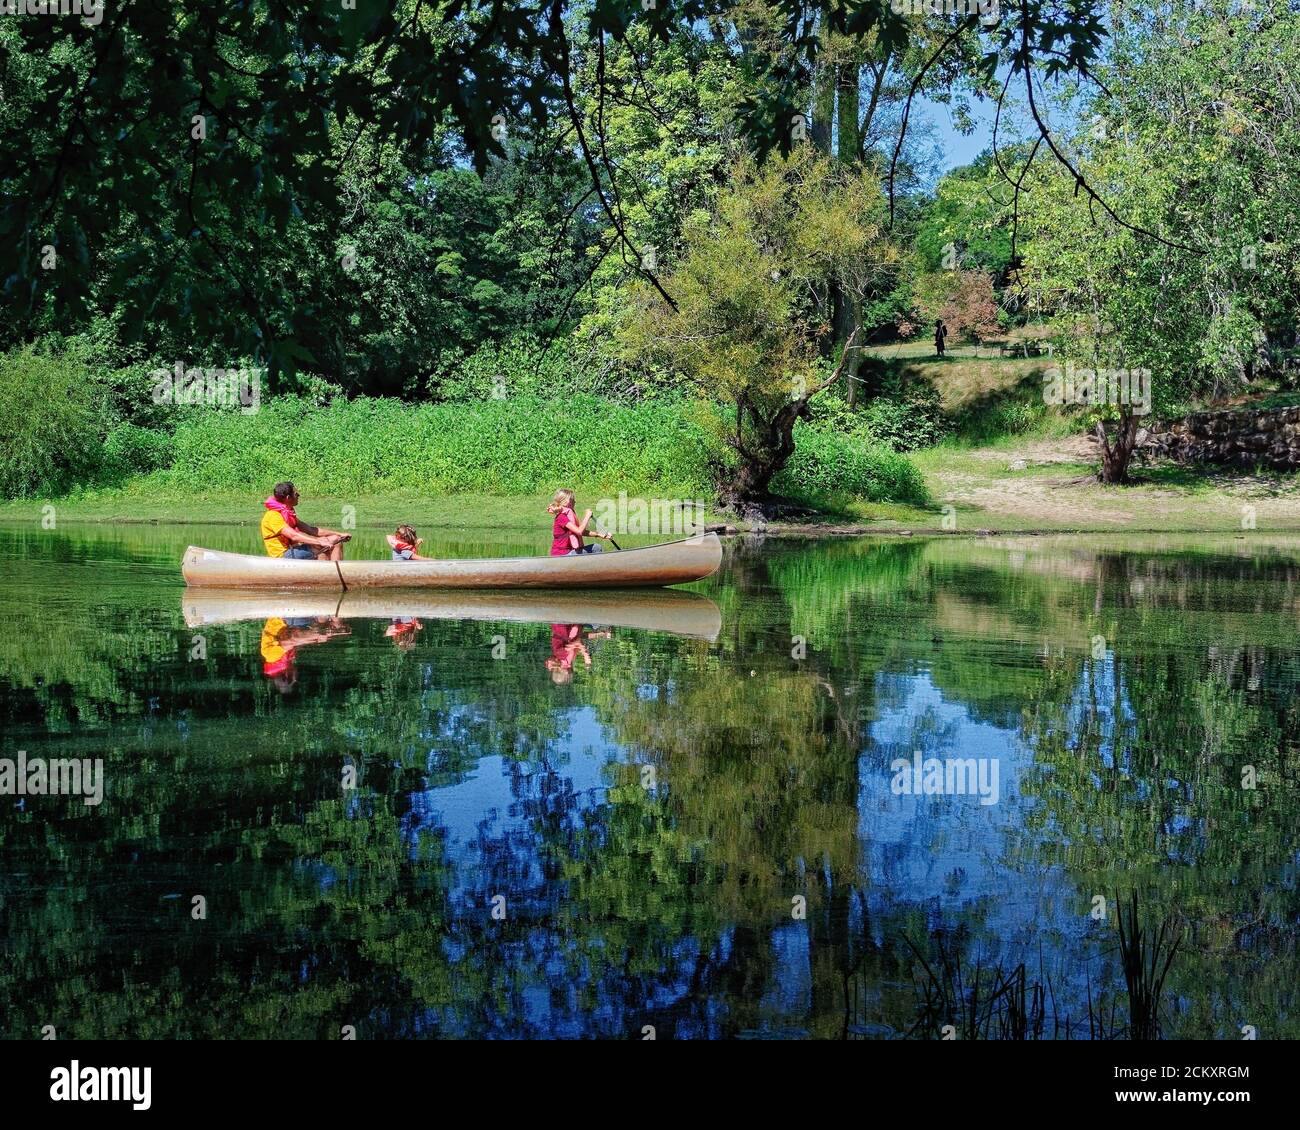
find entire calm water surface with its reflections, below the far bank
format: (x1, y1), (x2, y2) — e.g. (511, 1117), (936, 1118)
(0, 523), (1300, 1039)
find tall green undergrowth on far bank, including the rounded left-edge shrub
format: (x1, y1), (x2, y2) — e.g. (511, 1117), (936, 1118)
(0, 338), (924, 502)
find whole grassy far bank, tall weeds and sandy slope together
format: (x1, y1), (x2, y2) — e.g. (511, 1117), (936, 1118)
(10, 343), (1300, 536)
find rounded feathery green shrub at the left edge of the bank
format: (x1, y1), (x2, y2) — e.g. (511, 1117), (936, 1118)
(0, 347), (103, 498)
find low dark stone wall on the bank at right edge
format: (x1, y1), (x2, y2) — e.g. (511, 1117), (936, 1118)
(1138, 407), (1300, 471)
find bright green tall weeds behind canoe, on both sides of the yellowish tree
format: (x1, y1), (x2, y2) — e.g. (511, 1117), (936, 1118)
(155, 397), (926, 502)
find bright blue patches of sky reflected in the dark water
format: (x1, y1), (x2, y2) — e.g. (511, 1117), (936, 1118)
(403, 664), (1114, 1036)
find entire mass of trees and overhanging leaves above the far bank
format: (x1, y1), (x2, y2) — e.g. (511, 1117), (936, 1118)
(0, 0), (1300, 505)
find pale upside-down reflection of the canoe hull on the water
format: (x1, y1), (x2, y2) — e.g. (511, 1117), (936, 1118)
(182, 589), (722, 640)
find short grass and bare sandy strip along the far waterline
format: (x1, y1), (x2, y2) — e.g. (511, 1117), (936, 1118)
(10, 437), (1300, 534)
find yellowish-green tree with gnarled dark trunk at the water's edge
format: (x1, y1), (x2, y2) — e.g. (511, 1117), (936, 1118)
(619, 147), (897, 502)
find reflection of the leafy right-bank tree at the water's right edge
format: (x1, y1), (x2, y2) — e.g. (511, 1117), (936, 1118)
(1003, 558), (1300, 1038)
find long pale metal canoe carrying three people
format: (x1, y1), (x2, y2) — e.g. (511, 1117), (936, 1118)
(181, 533), (723, 590)
